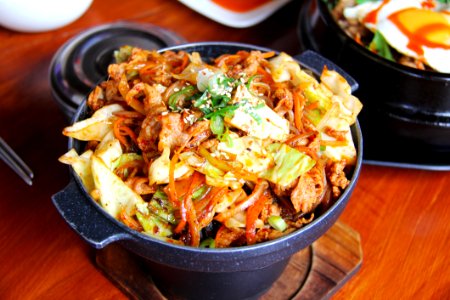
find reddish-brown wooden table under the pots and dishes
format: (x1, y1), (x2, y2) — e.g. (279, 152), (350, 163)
(0, 0), (450, 299)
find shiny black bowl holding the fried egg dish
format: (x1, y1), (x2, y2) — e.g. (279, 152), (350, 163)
(298, 0), (450, 170)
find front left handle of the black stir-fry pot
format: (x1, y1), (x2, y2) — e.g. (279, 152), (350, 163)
(52, 179), (131, 249)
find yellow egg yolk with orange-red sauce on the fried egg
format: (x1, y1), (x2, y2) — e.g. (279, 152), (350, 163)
(388, 8), (450, 55)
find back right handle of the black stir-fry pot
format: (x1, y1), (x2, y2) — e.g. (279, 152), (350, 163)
(295, 50), (359, 92)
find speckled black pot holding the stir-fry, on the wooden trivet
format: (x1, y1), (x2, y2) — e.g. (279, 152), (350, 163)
(52, 42), (362, 299)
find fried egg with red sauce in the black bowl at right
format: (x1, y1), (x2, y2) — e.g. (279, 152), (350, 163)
(344, 0), (450, 73)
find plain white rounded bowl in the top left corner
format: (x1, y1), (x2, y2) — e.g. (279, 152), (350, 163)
(0, 0), (93, 32)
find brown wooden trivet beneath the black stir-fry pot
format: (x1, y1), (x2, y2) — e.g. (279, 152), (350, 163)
(96, 221), (362, 300)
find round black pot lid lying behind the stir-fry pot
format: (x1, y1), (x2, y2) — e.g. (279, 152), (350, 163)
(50, 22), (185, 118)
